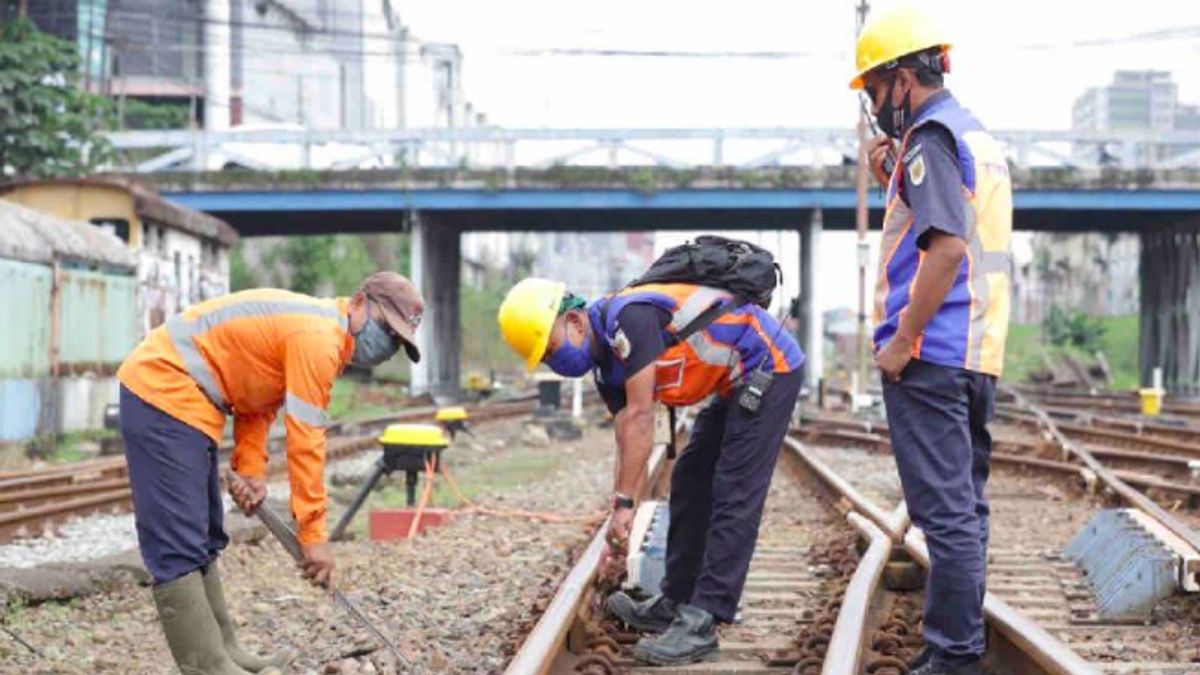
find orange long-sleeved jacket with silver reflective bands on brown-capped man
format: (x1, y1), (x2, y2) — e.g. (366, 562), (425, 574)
(116, 288), (354, 544)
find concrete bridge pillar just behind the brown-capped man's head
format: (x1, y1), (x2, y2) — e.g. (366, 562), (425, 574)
(412, 214), (462, 400)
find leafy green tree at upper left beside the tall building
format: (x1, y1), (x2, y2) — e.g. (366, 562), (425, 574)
(0, 18), (112, 178)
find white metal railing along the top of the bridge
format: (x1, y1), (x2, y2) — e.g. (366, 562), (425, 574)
(108, 127), (1200, 173)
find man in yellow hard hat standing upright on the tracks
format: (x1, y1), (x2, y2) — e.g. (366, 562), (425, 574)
(851, 7), (1013, 675)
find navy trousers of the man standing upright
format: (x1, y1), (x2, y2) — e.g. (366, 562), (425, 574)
(883, 359), (996, 665)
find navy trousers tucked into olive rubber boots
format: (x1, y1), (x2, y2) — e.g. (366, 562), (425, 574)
(121, 386), (229, 584)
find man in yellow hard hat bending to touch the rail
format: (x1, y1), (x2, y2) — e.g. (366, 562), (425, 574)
(499, 273), (804, 665)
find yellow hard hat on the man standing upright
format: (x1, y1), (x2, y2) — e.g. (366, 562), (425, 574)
(850, 5), (950, 89)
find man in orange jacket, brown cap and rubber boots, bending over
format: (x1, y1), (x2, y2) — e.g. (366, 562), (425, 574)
(118, 271), (424, 675)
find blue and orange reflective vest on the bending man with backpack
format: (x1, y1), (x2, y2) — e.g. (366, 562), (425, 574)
(588, 283), (804, 406)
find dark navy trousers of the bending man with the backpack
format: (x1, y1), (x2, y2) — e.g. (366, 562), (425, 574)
(662, 371), (802, 622)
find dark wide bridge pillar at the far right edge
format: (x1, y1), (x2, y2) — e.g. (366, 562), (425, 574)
(1139, 222), (1200, 395)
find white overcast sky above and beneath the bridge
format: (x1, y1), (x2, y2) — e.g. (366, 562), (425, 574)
(397, 0), (1200, 307)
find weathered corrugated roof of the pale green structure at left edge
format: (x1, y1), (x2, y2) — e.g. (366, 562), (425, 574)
(0, 199), (137, 269)
